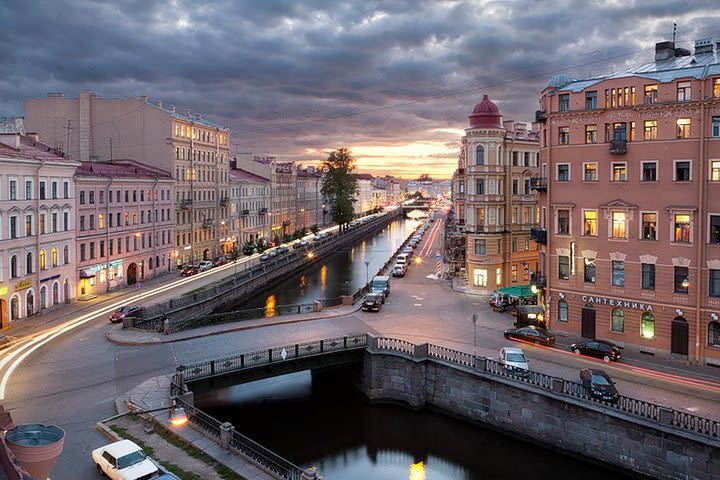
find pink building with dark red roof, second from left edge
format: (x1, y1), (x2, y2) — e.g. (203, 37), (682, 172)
(75, 160), (177, 298)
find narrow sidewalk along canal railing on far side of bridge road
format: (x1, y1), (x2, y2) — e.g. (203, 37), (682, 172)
(107, 306), (360, 345)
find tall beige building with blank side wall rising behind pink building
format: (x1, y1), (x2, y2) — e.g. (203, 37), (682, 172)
(25, 91), (231, 264)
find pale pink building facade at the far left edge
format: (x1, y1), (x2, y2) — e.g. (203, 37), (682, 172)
(0, 134), (79, 327)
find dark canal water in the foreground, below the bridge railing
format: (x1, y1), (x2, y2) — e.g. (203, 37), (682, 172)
(195, 370), (632, 480)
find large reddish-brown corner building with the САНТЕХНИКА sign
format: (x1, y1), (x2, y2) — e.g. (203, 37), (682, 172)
(536, 40), (720, 364)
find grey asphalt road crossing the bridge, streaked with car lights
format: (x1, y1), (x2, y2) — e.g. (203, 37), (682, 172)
(0, 208), (720, 480)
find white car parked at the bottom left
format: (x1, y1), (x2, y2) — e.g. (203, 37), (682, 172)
(92, 440), (160, 480)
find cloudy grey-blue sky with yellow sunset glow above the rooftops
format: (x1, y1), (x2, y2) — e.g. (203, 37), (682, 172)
(0, 0), (720, 177)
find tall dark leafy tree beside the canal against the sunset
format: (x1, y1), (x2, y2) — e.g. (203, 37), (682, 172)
(321, 147), (359, 231)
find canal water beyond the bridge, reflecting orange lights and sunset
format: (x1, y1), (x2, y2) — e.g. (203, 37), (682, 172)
(236, 218), (420, 310)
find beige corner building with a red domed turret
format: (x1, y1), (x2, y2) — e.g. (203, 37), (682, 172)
(448, 95), (540, 290)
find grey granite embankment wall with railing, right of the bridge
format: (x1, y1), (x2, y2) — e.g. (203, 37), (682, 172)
(357, 338), (720, 480)
